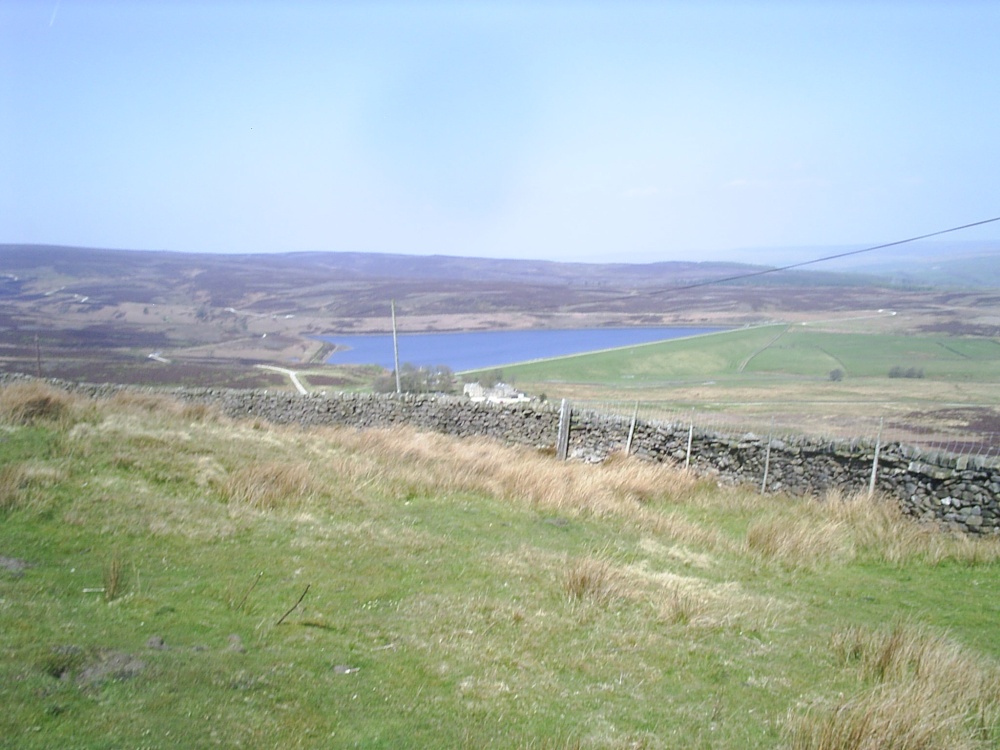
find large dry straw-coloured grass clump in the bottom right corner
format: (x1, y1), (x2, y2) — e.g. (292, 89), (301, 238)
(789, 624), (1000, 750)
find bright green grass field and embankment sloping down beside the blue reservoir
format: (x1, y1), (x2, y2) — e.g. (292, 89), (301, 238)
(488, 324), (1000, 388)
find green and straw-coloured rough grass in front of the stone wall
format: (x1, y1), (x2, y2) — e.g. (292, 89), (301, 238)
(0, 386), (1000, 748)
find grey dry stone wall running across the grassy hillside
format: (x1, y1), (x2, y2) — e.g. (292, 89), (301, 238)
(2, 376), (1000, 534)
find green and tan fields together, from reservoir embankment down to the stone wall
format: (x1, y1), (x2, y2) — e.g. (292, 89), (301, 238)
(490, 324), (1000, 444)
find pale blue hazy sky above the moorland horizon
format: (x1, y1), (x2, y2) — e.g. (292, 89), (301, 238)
(0, 0), (1000, 263)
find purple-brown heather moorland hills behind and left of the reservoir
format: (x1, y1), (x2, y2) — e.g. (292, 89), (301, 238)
(0, 245), (1000, 386)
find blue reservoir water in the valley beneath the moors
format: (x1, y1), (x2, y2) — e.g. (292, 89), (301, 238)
(321, 328), (724, 372)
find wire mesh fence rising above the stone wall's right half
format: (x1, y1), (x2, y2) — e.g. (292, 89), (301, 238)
(573, 400), (1000, 459)
